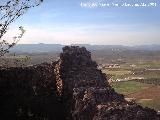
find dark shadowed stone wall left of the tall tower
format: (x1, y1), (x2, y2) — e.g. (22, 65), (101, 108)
(0, 63), (64, 120)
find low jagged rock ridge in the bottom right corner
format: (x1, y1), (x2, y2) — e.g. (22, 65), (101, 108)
(93, 103), (160, 120)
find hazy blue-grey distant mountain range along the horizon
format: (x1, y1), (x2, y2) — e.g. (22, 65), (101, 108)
(11, 43), (160, 53)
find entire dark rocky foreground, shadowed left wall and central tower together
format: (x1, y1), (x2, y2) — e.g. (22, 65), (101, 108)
(0, 46), (160, 120)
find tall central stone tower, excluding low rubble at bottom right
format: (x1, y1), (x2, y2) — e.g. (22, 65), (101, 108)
(58, 46), (124, 120)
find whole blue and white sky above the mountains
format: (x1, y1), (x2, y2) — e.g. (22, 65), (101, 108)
(5, 0), (160, 46)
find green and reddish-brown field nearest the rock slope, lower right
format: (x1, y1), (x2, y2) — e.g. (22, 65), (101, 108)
(112, 81), (160, 110)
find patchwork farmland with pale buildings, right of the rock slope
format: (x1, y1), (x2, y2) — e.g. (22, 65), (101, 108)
(102, 60), (160, 110)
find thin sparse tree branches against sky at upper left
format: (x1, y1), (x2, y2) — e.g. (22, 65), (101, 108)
(0, 0), (43, 57)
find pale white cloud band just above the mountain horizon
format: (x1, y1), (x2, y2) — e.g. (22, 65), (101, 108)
(5, 25), (160, 45)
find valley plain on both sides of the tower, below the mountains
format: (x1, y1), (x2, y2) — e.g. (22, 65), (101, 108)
(0, 48), (160, 110)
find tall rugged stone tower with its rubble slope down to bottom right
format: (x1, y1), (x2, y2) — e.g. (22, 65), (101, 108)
(55, 46), (159, 120)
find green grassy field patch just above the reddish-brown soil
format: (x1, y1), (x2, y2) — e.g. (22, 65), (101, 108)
(111, 81), (150, 95)
